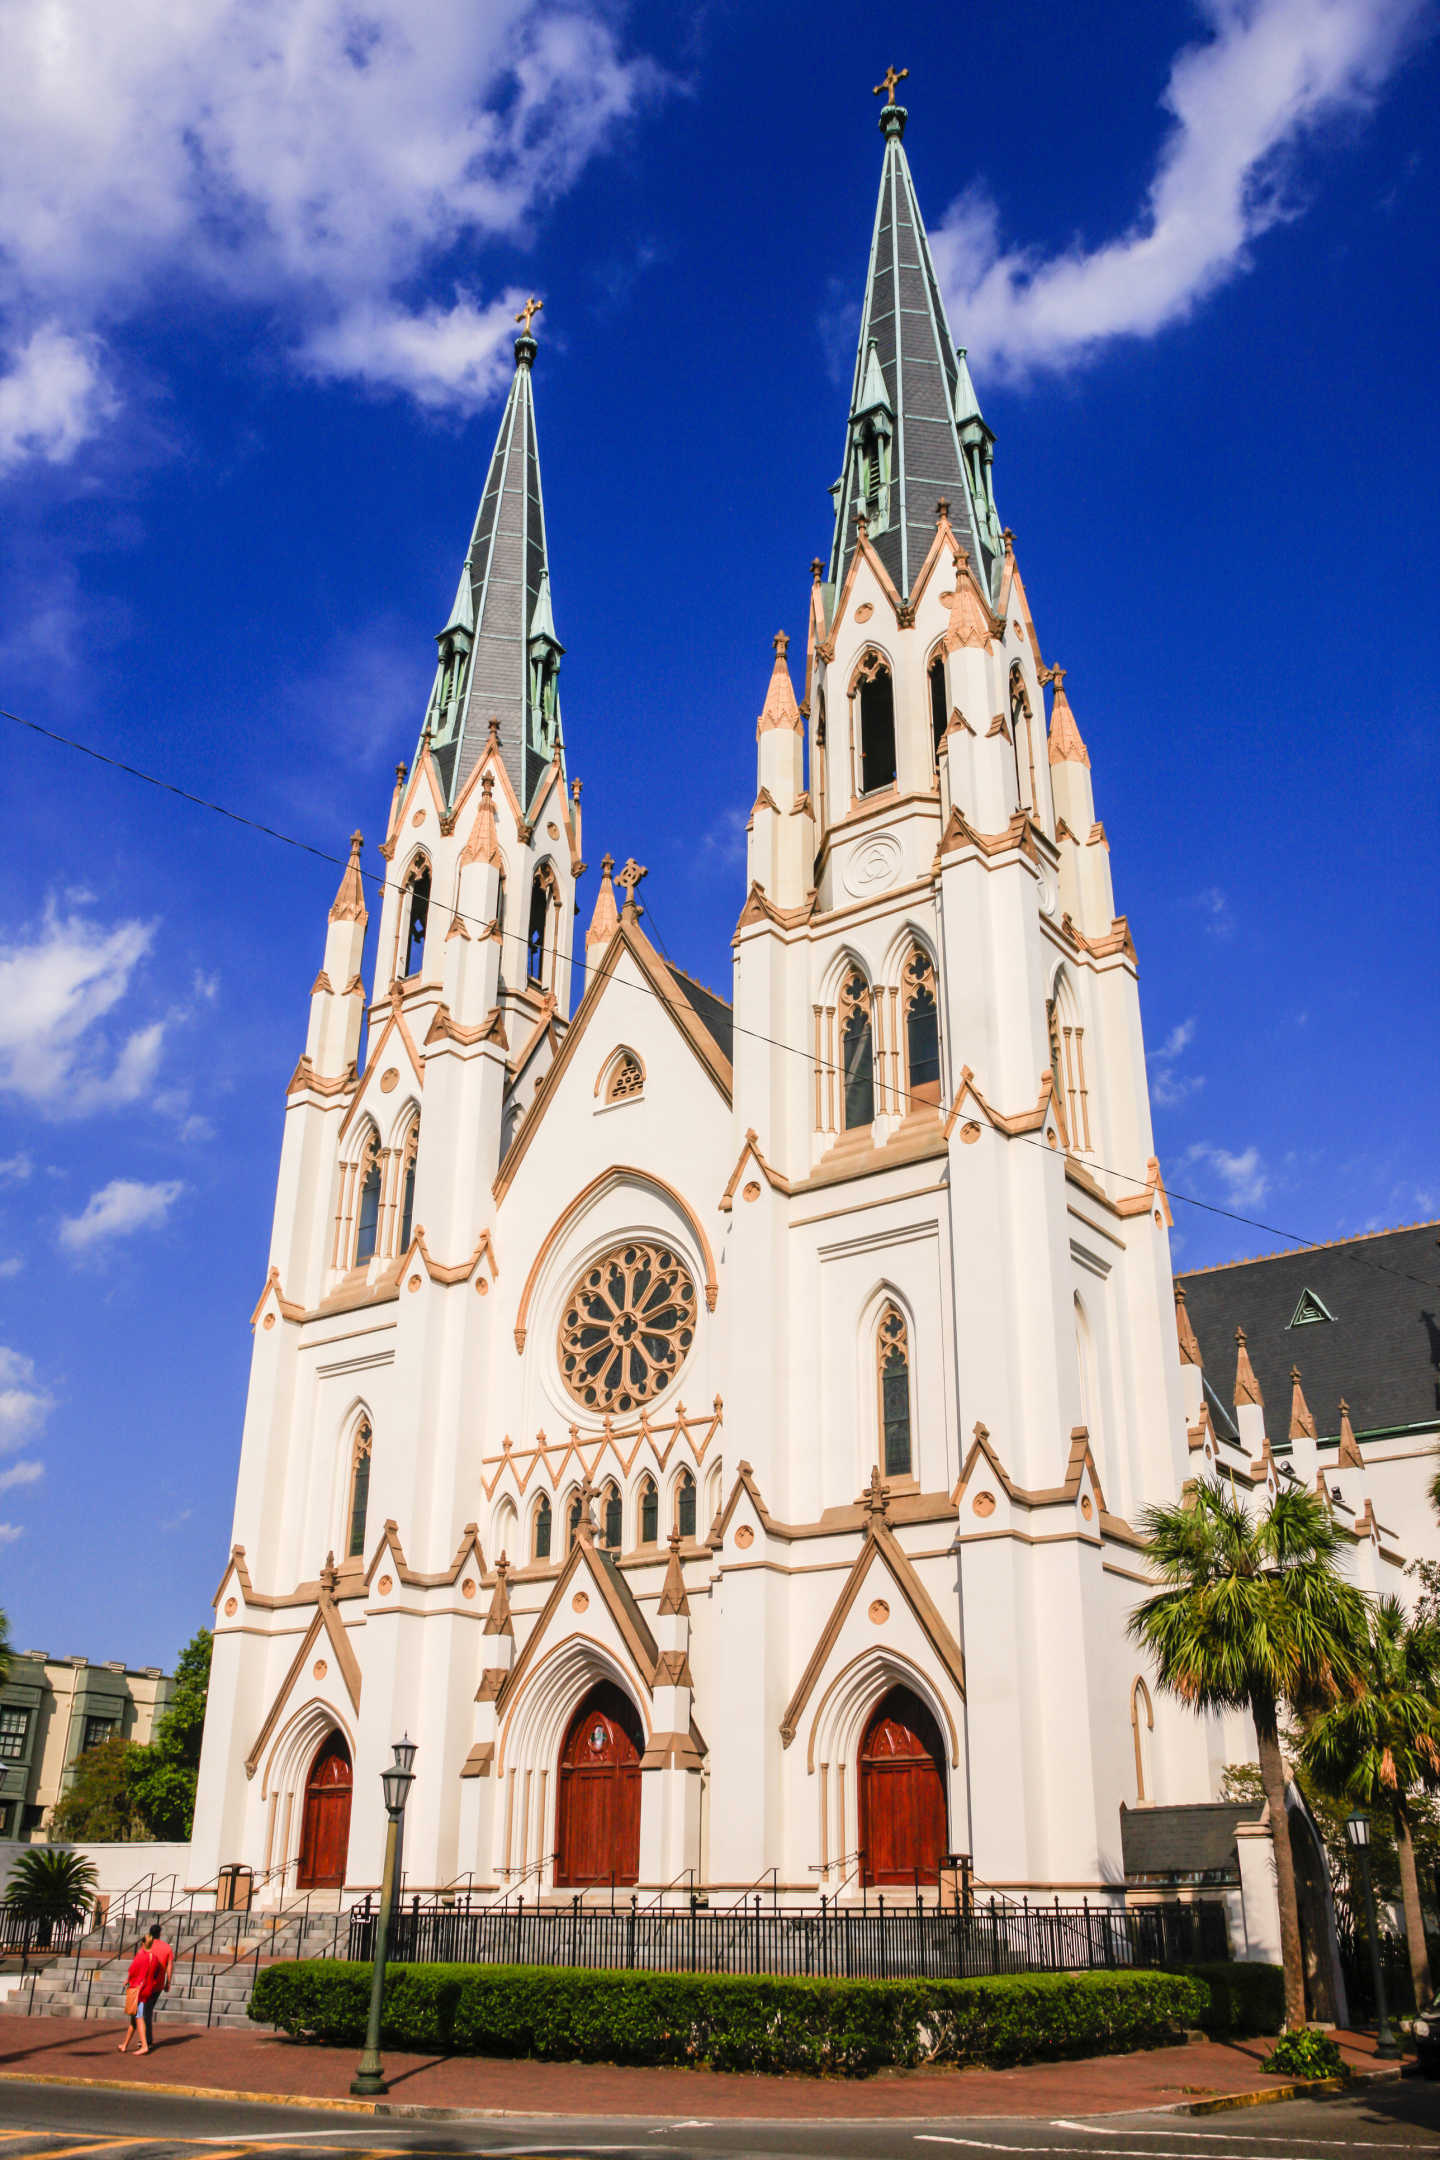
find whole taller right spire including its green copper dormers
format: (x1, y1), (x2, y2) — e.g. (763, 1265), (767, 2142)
(829, 86), (1004, 598)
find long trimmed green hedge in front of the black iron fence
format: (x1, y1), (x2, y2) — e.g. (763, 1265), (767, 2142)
(250, 1959), (1248, 2076)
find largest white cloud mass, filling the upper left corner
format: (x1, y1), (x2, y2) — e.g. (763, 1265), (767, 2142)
(0, 0), (663, 458)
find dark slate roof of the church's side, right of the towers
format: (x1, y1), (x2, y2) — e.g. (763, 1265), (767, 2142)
(1179, 1223), (1440, 1443)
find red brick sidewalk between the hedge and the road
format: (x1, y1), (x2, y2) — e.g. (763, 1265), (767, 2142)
(0, 2015), (1407, 2121)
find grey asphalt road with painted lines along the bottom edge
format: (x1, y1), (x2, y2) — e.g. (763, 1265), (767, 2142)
(0, 2078), (1440, 2160)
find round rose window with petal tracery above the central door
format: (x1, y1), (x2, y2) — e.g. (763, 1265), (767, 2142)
(559, 1240), (695, 1410)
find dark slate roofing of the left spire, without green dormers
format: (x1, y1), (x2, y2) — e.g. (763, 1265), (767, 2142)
(423, 337), (551, 808)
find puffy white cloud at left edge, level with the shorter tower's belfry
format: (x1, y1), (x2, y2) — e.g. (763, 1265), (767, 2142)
(0, 903), (164, 1117)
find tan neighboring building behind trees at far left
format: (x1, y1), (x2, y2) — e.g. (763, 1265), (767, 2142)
(0, 1650), (175, 1838)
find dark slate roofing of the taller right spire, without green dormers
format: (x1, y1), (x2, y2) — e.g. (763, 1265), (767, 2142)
(829, 106), (993, 598)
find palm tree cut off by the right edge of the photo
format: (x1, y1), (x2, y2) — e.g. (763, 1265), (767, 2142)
(1304, 1596), (1440, 2011)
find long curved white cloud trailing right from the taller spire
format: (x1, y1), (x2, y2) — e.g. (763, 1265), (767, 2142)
(933, 0), (1427, 374)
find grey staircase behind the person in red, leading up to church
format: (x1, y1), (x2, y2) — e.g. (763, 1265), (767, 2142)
(15, 1905), (350, 2026)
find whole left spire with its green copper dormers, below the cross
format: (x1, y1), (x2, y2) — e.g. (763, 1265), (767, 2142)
(425, 315), (566, 808)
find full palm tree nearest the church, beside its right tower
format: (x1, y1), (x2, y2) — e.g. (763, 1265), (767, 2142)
(1129, 1477), (1367, 2026)
